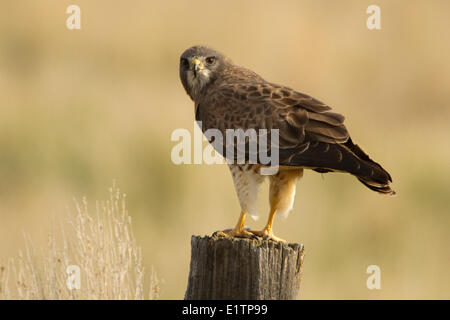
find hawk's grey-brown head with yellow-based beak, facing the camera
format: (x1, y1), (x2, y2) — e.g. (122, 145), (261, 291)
(180, 46), (230, 101)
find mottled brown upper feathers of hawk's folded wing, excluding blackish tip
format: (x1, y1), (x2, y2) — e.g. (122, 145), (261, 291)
(197, 82), (349, 158)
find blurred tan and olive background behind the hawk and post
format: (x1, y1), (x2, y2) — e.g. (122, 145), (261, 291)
(0, 0), (450, 299)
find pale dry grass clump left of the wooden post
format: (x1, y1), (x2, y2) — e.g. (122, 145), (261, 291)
(0, 186), (159, 299)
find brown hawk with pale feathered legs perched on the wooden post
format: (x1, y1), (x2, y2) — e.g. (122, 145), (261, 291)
(180, 46), (395, 241)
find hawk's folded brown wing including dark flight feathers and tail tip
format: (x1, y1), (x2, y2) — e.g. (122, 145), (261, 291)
(196, 81), (393, 193)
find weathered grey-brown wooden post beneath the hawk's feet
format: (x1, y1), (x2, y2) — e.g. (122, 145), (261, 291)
(184, 236), (304, 300)
